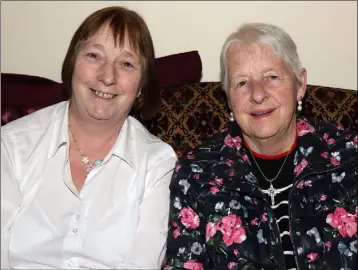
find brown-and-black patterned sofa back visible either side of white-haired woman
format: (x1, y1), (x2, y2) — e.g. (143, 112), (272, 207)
(137, 82), (358, 158)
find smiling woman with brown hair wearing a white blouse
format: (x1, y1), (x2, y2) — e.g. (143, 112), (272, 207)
(1, 7), (177, 269)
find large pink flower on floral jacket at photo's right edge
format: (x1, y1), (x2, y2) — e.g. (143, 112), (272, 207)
(326, 207), (357, 237)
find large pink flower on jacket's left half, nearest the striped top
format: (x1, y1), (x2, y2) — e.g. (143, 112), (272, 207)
(219, 214), (246, 246)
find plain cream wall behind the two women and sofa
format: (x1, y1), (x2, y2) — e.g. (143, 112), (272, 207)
(1, 1), (357, 90)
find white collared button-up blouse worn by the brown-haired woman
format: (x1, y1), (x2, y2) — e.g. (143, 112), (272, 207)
(1, 101), (177, 269)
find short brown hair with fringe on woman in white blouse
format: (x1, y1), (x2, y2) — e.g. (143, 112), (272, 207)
(61, 6), (160, 120)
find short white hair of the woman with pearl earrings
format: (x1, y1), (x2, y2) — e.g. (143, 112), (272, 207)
(220, 23), (302, 93)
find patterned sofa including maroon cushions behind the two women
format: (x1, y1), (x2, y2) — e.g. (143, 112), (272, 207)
(1, 51), (358, 158)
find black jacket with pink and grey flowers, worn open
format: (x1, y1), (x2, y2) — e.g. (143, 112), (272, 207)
(163, 118), (358, 270)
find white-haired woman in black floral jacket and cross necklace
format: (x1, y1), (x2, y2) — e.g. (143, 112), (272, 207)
(163, 23), (358, 270)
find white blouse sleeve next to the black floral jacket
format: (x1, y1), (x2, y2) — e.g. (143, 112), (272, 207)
(123, 157), (177, 269)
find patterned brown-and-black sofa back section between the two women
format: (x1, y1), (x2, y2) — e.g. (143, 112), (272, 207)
(136, 82), (229, 157)
